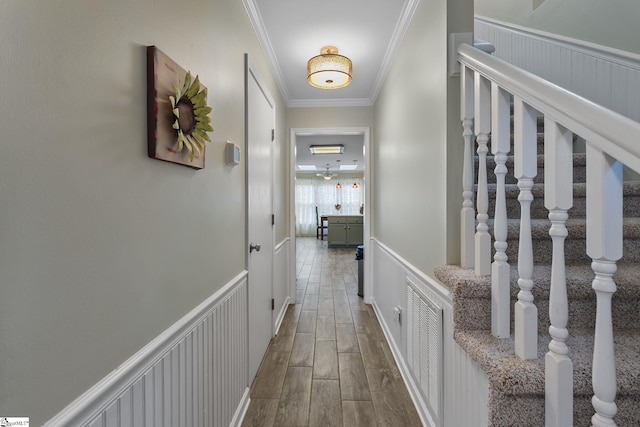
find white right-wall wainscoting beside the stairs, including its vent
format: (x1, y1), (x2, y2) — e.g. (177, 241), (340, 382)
(371, 239), (489, 427)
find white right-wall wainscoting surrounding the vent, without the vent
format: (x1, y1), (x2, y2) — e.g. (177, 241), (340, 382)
(369, 239), (488, 427)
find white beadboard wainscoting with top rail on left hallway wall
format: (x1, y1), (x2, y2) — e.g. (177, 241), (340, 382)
(45, 272), (249, 427)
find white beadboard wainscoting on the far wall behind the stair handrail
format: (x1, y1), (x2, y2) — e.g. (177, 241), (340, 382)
(474, 16), (640, 122)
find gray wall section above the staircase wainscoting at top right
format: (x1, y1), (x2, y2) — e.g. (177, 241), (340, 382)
(475, 0), (640, 53)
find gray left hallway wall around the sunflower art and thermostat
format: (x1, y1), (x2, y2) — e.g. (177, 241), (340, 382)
(0, 0), (288, 425)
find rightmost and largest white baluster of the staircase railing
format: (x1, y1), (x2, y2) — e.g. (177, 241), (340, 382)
(587, 141), (623, 427)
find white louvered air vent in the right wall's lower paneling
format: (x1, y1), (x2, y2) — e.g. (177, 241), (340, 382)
(406, 277), (443, 425)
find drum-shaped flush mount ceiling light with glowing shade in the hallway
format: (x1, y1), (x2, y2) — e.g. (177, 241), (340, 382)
(307, 46), (352, 89)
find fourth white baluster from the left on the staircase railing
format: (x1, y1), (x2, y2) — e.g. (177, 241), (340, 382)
(513, 96), (538, 359)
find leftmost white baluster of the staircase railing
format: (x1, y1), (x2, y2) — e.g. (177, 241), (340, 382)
(460, 65), (476, 268)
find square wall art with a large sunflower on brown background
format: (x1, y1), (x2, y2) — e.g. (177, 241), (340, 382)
(147, 46), (213, 169)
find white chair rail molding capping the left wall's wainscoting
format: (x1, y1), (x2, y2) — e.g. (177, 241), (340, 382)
(44, 270), (247, 427)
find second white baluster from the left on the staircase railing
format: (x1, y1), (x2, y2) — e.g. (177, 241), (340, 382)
(474, 73), (491, 276)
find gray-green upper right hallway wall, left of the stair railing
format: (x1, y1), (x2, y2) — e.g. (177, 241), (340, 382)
(372, 0), (447, 274)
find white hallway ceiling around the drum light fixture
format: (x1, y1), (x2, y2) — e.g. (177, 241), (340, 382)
(243, 0), (419, 107)
